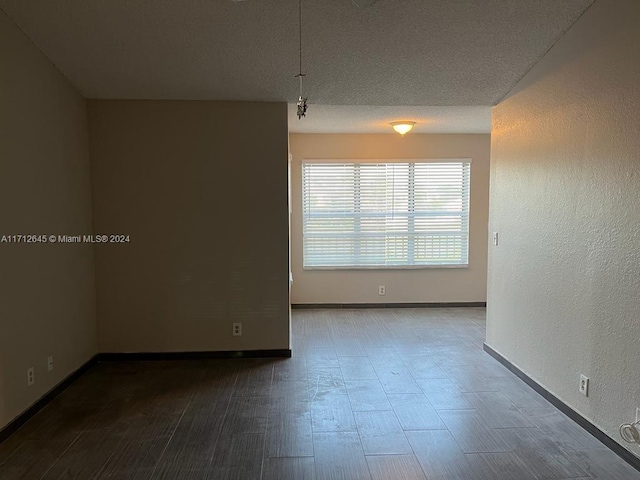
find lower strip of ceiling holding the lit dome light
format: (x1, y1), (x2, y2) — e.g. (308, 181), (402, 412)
(289, 104), (491, 135)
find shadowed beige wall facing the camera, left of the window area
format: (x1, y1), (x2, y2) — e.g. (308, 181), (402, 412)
(89, 101), (289, 352)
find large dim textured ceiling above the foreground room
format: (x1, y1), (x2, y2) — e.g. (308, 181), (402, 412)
(0, 0), (592, 106)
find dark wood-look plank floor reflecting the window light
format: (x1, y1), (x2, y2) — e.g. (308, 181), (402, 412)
(0, 308), (640, 480)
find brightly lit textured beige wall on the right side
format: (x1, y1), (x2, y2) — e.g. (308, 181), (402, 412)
(487, 0), (640, 453)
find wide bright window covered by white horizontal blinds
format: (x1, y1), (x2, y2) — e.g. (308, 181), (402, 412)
(302, 160), (470, 268)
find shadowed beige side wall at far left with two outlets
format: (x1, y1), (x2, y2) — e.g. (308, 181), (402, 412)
(0, 12), (96, 428)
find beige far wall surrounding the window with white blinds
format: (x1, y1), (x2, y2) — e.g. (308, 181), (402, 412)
(290, 134), (490, 304)
